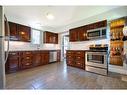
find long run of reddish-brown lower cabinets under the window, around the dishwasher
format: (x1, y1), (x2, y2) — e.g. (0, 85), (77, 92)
(5, 50), (60, 73)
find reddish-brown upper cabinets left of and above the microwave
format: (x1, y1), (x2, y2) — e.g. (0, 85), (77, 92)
(69, 20), (107, 42)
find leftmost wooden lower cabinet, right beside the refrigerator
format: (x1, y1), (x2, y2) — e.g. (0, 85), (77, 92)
(5, 52), (20, 73)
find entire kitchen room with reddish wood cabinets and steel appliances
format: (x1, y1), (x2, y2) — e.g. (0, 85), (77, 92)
(0, 6), (127, 89)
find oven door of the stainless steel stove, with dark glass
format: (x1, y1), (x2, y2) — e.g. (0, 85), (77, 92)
(86, 52), (107, 68)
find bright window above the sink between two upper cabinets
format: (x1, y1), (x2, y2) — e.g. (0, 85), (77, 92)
(31, 29), (41, 45)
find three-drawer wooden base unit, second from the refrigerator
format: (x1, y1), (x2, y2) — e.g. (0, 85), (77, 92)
(20, 51), (33, 69)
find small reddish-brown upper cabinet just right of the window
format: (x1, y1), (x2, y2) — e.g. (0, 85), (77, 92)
(43, 31), (58, 44)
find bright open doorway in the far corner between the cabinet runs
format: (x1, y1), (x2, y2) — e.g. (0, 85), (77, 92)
(62, 35), (70, 59)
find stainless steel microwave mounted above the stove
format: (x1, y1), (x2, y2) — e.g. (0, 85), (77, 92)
(87, 27), (107, 39)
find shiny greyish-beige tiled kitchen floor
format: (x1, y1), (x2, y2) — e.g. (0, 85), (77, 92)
(6, 62), (127, 89)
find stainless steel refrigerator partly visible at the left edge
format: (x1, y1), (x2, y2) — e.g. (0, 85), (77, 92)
(0, 6), (10, 89)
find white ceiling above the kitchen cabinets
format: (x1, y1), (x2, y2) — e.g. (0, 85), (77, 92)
(4, 6), (118, 28)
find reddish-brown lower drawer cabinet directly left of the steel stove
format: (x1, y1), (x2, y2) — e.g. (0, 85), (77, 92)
(66, 50), (85, 69)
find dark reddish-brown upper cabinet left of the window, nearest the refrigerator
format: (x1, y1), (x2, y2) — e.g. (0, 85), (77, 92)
(5, 22), (31, 42)
